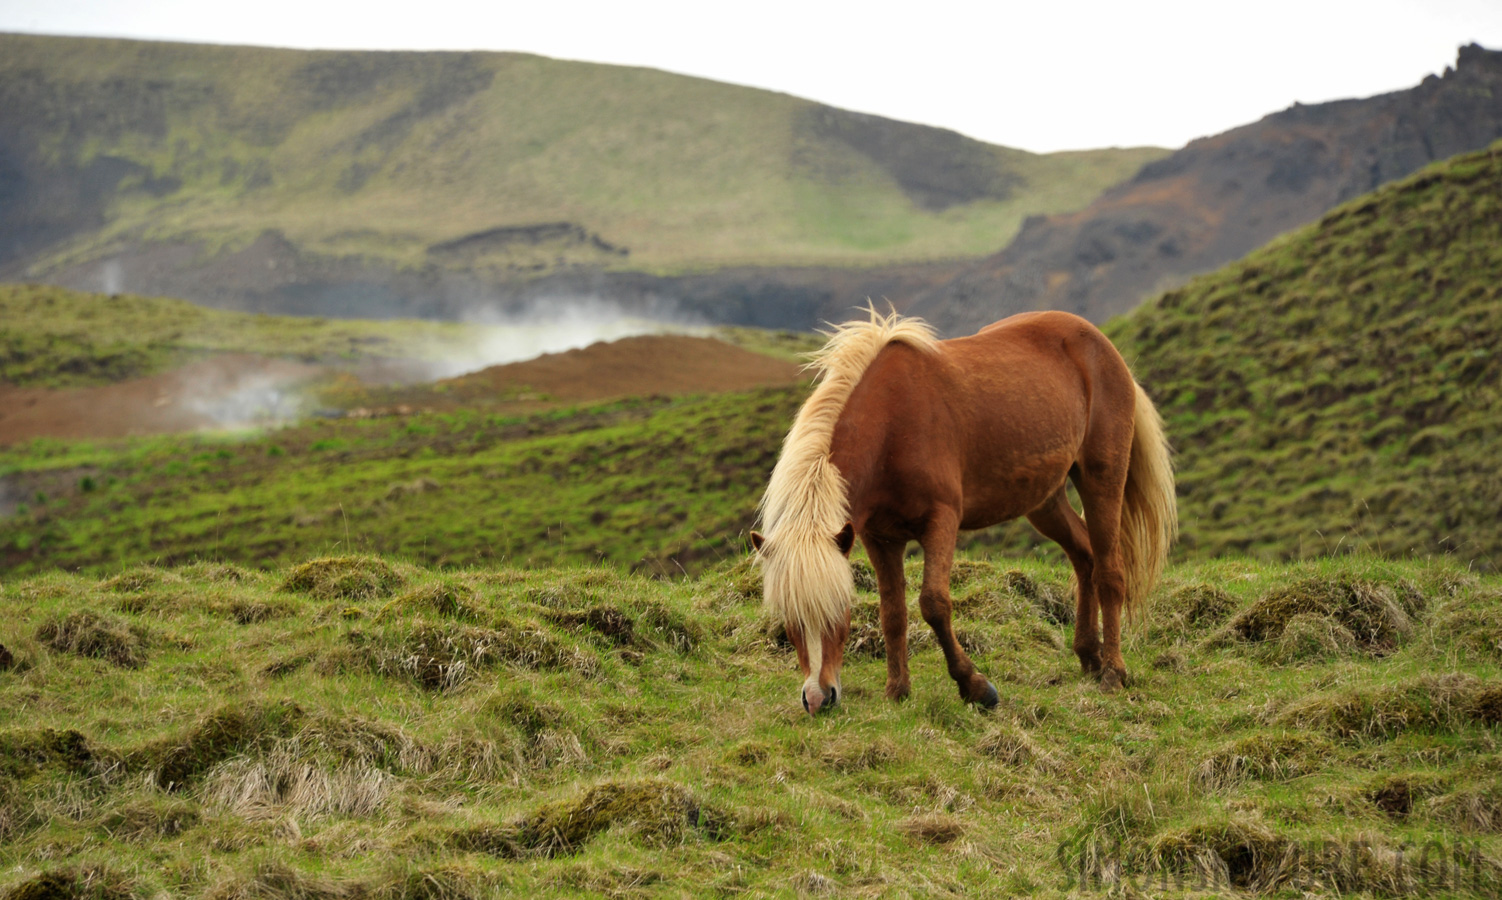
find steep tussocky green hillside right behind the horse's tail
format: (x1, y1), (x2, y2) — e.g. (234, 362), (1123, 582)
(1108, 143), (1502, 568)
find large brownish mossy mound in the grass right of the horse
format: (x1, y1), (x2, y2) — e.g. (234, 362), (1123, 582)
(1227, 575), (1422, 654)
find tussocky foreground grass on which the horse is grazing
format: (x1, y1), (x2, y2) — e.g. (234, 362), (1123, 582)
(0, 556), (1502, 900)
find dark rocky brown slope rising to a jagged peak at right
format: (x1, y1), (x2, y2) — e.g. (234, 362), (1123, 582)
(910, 45), (1502, 335)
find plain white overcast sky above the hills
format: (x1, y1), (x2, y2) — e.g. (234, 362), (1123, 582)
(0, 0), (1502, 152)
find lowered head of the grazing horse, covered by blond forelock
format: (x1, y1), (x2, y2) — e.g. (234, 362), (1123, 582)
(751, 521), (855, 715)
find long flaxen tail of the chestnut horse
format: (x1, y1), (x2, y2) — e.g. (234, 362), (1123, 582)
(1120, 385), (1179, 615)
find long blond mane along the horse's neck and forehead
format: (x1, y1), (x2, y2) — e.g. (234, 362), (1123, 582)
(760, 307), (939, 636)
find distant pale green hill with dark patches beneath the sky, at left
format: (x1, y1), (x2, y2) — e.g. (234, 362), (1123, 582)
(0, 35), (1163, 276)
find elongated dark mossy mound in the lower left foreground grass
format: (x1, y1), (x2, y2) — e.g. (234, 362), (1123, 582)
(135, 702), (306, 790)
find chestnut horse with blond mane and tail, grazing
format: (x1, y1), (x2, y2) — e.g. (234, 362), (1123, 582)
(751, 308), (1178, 714)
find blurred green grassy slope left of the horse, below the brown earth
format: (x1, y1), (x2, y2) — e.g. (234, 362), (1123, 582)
(0, 388), (802, 574)
